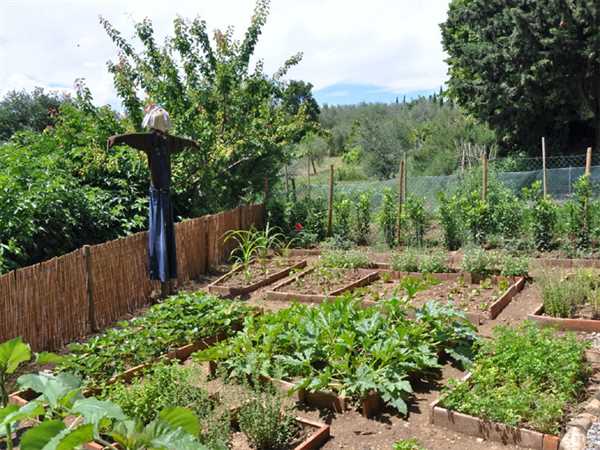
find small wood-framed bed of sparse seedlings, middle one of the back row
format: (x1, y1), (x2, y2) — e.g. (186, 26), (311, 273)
(266, 267), (379, 303)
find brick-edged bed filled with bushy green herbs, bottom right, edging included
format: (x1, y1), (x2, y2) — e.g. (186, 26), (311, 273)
(430, 322), (589, 450)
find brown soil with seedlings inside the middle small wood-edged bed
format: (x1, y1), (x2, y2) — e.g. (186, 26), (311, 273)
(277, 267), (365, 295)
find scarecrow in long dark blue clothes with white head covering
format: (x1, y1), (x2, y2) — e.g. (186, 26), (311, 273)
(107, 104), (198, 296)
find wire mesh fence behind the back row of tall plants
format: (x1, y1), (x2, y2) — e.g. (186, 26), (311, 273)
(296, 155), (600, 208)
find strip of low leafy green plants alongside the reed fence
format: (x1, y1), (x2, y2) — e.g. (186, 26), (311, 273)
(58, 292), (252, 383)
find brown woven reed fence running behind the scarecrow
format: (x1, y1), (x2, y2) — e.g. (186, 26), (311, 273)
(0, 205), (264, 351)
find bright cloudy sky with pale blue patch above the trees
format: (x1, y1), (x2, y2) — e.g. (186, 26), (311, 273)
(0, 0), (449, 108)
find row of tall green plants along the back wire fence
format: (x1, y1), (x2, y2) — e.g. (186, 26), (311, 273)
(268, 167), (600, 257)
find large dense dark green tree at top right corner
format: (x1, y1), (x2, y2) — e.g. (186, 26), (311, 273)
(441, 0), (600, 153)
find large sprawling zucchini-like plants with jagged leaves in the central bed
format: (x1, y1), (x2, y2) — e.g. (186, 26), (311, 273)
(195, 296), (476, 413)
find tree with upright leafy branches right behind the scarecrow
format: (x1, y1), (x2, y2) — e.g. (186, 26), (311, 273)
(101, 0), (317, 214)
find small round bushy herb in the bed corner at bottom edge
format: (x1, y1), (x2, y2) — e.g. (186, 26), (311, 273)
(238, 391), (298, 450)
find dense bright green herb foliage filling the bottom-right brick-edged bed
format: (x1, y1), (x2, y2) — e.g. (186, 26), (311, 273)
(442, 322), (588, 434)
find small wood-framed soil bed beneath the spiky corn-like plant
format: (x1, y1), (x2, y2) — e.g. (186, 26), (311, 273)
(208, 257), (306, 297)
